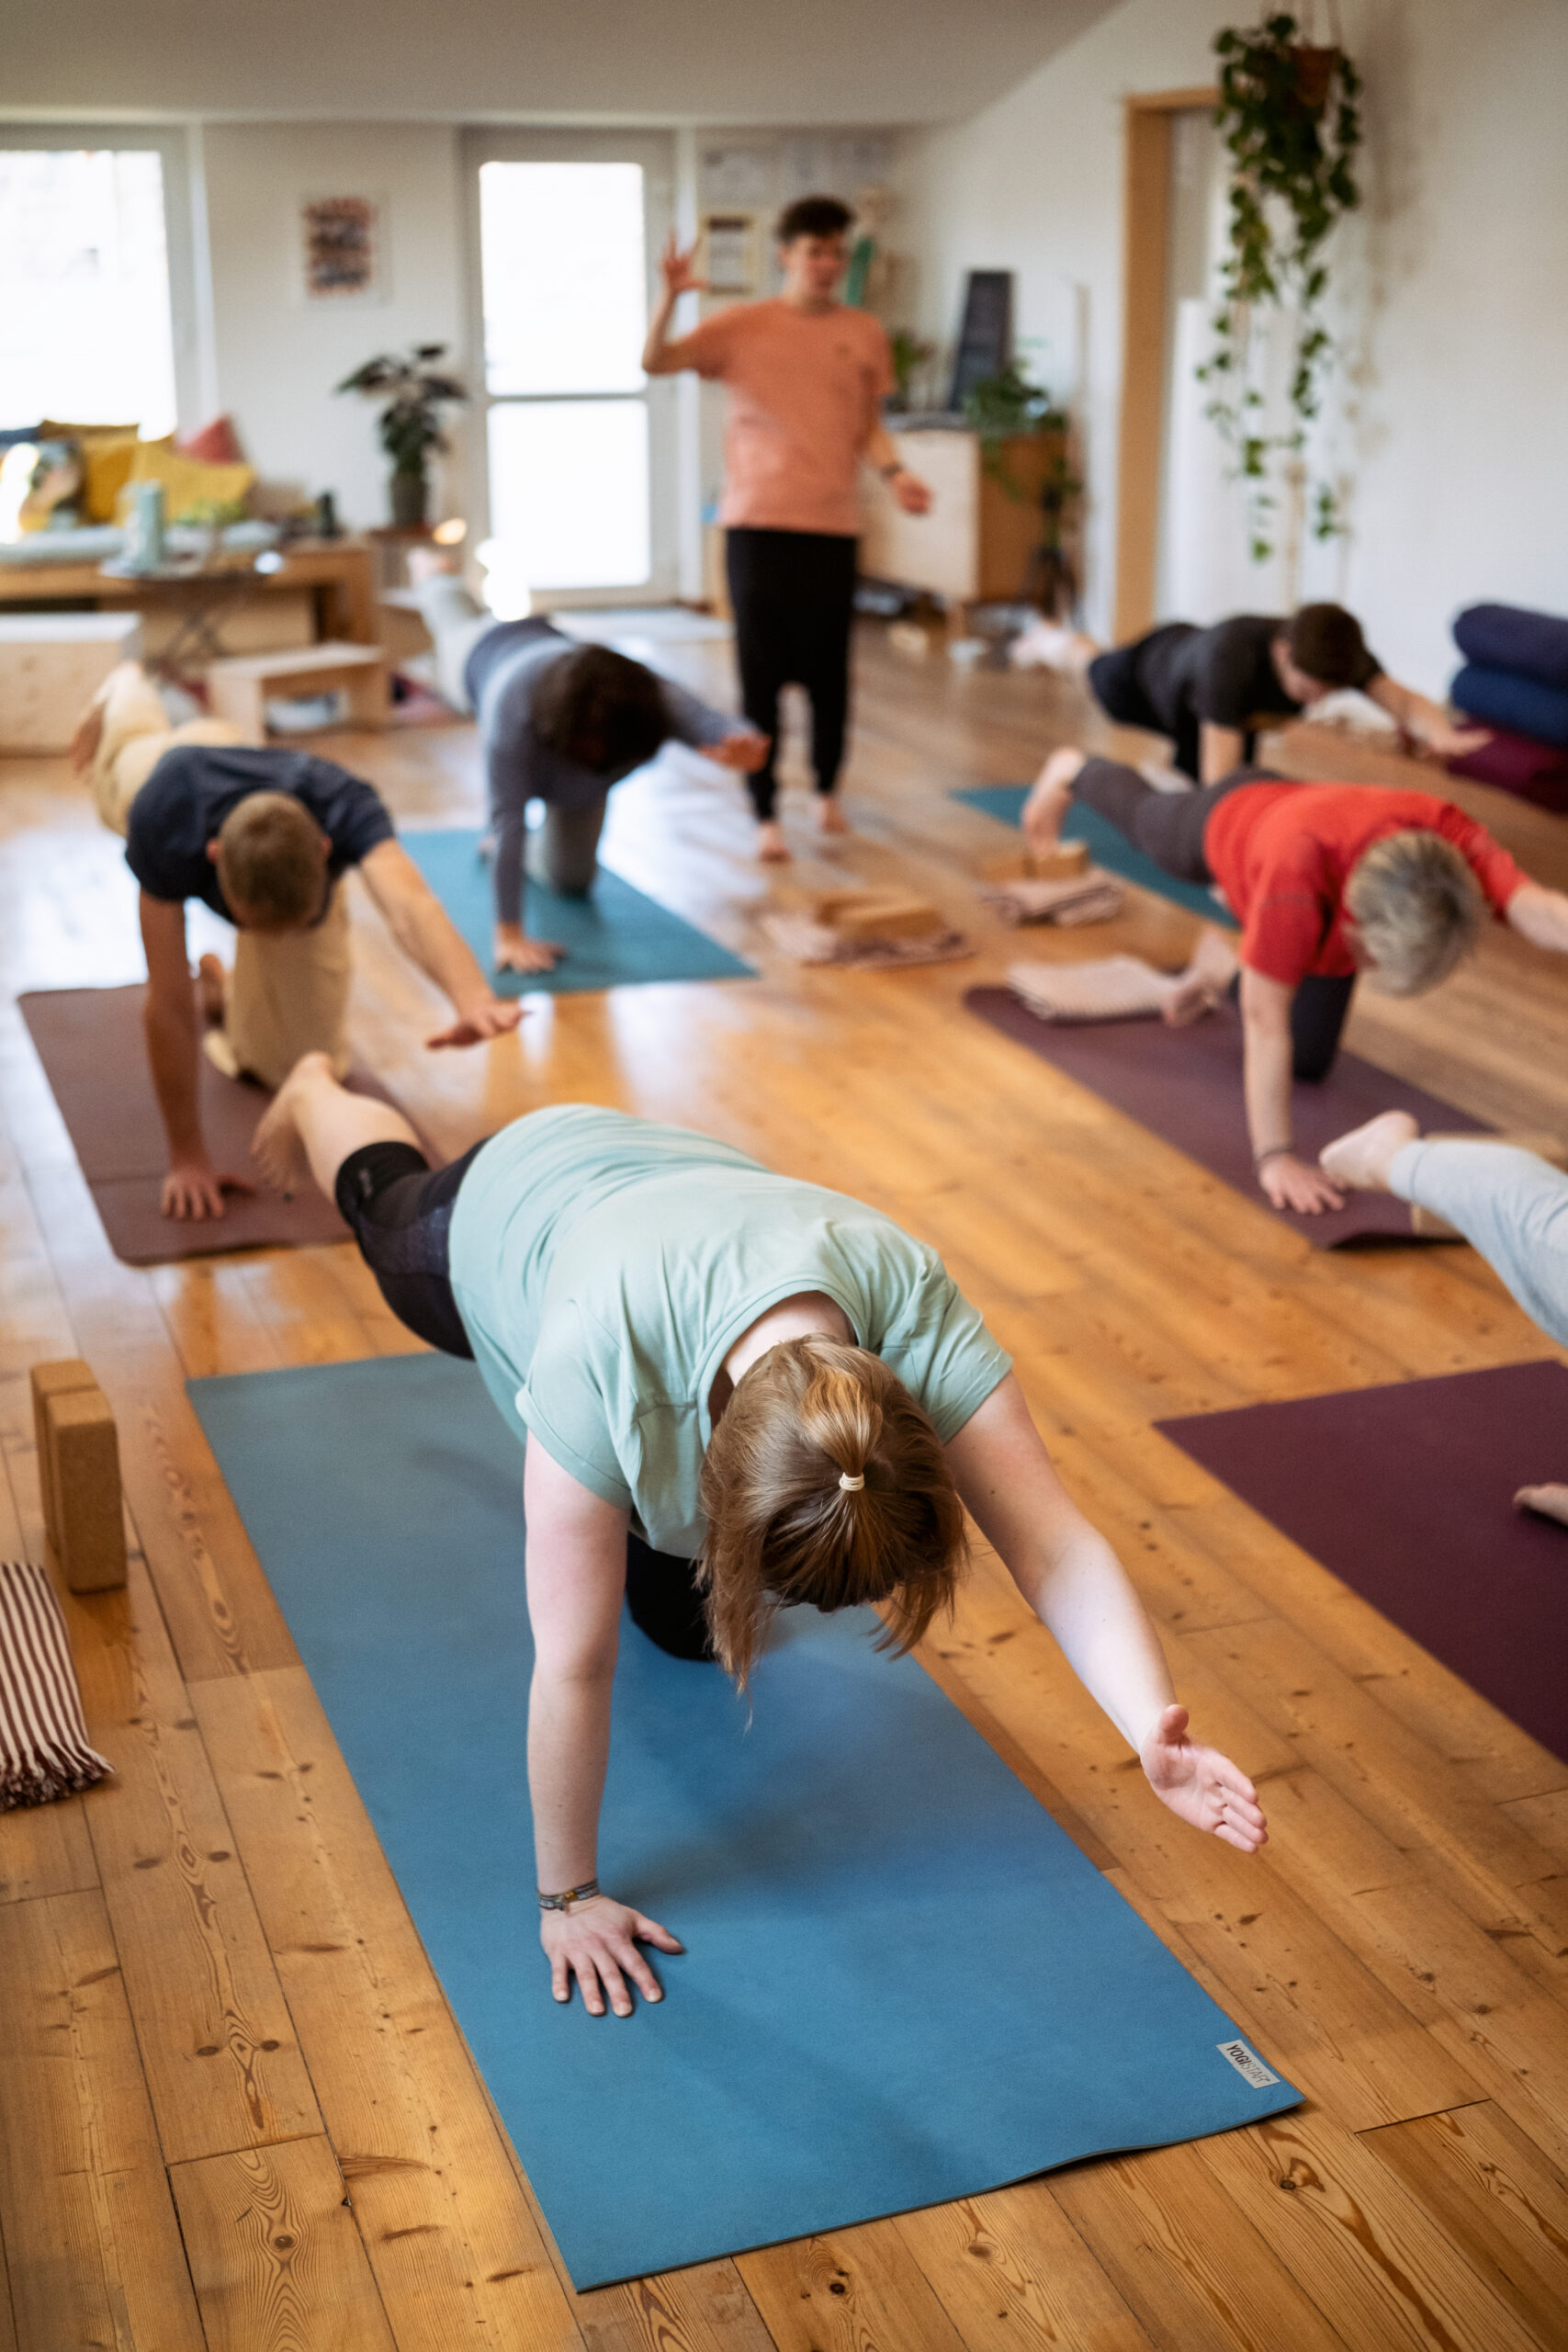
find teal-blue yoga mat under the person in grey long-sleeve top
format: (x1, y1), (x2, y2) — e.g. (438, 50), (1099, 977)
(398, 826), (757, 997)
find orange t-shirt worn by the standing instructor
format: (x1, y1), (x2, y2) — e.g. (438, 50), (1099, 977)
(668, 301), (894, 538)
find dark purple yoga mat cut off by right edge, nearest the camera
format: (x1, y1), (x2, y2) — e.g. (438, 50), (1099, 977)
(1155, 1364), (1568, 1761)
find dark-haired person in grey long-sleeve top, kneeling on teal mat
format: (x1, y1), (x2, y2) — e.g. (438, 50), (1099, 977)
(419, 576), (769, 971)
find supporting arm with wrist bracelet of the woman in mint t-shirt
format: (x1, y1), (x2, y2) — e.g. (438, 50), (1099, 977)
(522, 1437), (682, 2018)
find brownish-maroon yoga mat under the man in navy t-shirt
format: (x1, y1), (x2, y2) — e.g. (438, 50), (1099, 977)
(18, 988), (411, 1265)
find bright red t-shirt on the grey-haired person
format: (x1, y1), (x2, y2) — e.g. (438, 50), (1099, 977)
(1203, 783), (1530, 988)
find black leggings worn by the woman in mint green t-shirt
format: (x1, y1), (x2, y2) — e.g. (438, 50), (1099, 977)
(333, 1138), (712, 1660)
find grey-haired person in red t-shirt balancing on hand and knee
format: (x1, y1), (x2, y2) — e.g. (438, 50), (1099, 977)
(1022, 751), (1568, 1211)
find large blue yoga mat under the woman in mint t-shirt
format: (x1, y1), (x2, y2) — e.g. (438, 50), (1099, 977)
(190, 1355), (1298, 2289)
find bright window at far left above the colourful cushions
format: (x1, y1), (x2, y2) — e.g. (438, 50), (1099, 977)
(0, 147), (176, 435)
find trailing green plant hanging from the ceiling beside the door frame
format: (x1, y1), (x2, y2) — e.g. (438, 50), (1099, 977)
(1197, 14), (1361, 562)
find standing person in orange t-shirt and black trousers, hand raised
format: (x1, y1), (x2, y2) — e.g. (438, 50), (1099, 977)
(642, 195), (931, 858)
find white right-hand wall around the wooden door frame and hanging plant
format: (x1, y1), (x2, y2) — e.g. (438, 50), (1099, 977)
(896, 0), (1568, 692)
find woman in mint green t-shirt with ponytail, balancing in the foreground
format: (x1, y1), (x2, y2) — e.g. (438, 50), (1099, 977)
(256, 1054), (1267, 2016)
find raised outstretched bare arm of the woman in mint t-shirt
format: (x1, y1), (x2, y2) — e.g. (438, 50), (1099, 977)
(947, 1374), (1267, 1853)
